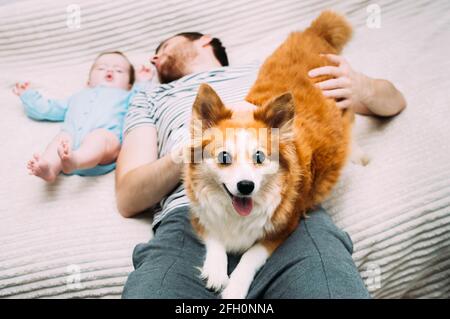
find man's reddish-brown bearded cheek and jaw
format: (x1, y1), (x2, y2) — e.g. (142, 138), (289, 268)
(158, 45), (197, 84)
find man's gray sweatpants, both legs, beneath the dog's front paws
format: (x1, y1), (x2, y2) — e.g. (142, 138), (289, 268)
(122, 207), (370, 299)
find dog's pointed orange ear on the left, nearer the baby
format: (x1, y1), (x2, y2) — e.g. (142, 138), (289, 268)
(192, 84), (233, 130)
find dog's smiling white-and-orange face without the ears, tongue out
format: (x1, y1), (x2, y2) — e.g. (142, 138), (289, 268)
(203, 121), (278, 216)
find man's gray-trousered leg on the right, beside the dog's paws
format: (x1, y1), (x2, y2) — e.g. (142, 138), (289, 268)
(248, 208), (370, 299)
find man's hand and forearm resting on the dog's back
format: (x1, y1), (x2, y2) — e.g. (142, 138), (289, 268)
(309, 54), (406, 116)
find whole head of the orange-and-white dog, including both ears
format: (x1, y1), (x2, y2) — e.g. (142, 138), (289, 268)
(186, 85), (294, 220)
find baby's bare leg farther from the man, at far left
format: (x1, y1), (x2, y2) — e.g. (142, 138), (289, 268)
(27, 132), (71, 182)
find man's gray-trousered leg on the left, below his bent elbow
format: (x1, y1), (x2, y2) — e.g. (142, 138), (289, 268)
(122, 207), (217, 299)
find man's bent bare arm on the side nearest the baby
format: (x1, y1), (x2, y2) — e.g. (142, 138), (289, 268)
(116, 125), (183, 217)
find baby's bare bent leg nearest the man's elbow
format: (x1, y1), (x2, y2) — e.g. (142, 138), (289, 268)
(58, 129), (120, 174)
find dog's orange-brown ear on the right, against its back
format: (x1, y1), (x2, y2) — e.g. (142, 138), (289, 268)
(253, 93), (295, 130)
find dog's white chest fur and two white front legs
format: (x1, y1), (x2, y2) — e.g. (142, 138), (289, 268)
(192, 182), (280, 299)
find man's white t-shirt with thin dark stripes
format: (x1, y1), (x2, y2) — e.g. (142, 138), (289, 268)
(124, 63), (259, 225)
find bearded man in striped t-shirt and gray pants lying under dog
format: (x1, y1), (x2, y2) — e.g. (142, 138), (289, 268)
(116, 33), (406, 299)
